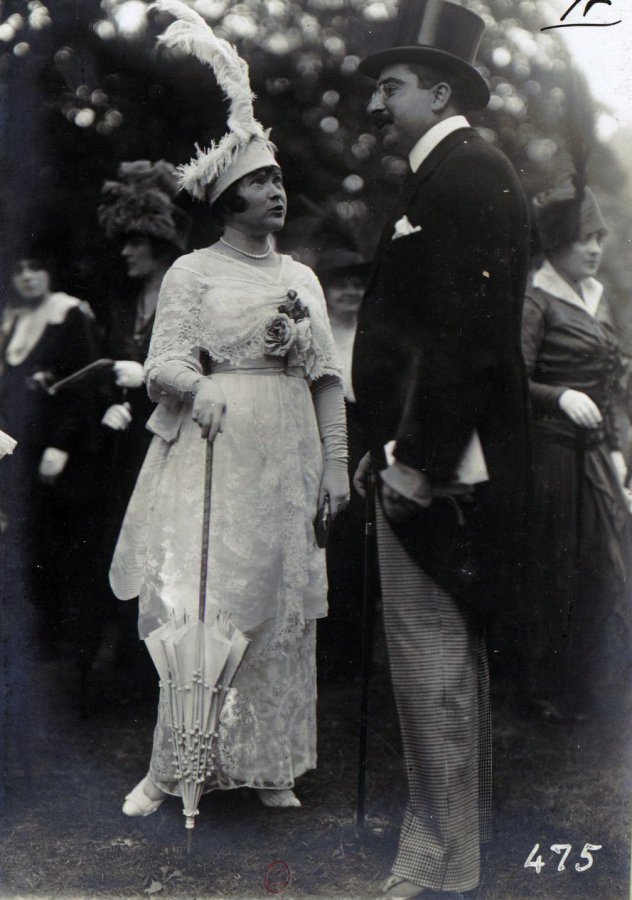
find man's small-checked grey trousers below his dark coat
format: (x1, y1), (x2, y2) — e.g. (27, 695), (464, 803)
(376, 500), (491, 892)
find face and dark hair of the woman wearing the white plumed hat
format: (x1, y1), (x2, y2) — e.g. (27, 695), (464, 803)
(226, 166), (287, 237)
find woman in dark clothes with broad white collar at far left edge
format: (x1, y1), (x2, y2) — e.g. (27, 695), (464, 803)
(0, 252), (96, 647)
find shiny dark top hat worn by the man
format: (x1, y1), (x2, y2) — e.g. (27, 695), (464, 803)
(360, 0), (490, 109)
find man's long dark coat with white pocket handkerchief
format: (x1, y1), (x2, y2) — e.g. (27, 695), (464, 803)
(353, 128), (529, 609)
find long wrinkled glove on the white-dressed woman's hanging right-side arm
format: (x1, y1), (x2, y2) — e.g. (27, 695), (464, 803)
(312, 376), (349, 521)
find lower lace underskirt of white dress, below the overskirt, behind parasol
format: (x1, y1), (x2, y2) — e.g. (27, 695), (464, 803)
(149, 621), (316, 795)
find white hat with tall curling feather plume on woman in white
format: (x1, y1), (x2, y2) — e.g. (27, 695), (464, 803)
(150, 0), (278, 204)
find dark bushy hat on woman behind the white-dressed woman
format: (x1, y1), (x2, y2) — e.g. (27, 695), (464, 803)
(97, 159), (189, 250)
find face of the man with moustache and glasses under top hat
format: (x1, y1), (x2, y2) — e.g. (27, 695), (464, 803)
(367, 63), (438, 156)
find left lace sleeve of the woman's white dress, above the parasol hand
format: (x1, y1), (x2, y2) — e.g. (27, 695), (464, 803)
(145, 263), (203, 402)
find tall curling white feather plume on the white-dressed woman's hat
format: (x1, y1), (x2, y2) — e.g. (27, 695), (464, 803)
(150, 0), (272, 200)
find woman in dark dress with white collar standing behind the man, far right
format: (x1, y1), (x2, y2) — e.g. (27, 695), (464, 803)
(523, 184), (632, 720)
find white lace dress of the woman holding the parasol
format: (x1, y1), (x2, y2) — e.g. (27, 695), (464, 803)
(110, 248), (340, 793)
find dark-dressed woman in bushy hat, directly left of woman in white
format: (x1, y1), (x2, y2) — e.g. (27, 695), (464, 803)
(83, 159), (189, 669)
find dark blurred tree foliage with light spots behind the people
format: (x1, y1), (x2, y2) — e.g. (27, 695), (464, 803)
(0, 0), (632, 345)
